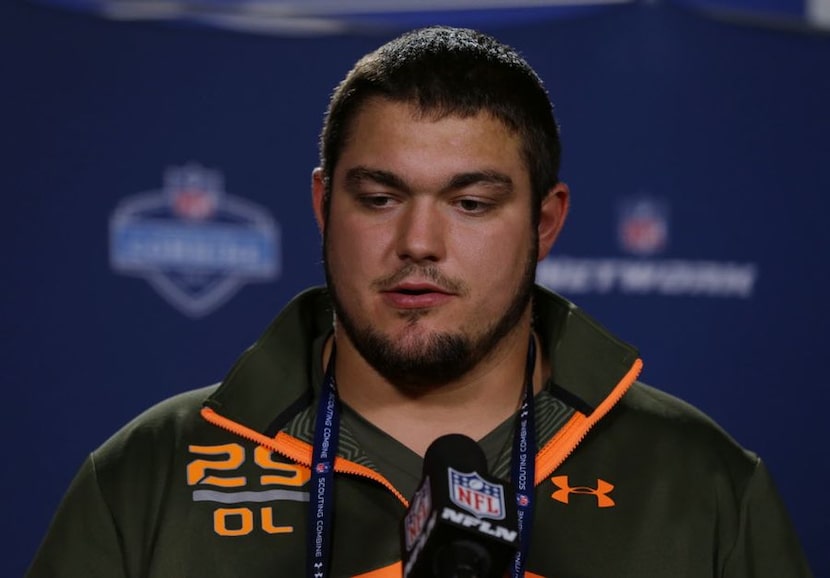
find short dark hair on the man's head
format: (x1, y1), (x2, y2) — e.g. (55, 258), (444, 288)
(320, 26), (561, 220)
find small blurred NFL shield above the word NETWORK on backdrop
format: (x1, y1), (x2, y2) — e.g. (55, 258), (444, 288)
(617, 196), (669, 257)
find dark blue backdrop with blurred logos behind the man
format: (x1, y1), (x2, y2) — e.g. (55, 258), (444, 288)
(0, 0), (830, 577)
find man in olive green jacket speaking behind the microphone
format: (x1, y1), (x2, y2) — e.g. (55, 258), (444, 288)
(29, 23), (810, 578)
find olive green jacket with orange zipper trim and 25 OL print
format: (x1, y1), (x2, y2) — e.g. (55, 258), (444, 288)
(28, 288), (810, 578)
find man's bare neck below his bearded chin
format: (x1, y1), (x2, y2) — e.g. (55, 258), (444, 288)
(323, 313), (549, 456)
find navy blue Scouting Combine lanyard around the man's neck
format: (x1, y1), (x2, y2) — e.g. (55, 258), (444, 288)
(306, 337), (536, 578)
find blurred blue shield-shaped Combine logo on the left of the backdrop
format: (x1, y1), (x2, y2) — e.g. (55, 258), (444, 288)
(110, 164), (281, 317)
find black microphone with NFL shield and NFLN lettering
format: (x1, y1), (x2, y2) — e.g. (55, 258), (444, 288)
(402, 434), (519, 578)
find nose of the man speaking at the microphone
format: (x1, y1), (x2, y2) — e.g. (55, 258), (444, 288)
(396, 198), (446, 262)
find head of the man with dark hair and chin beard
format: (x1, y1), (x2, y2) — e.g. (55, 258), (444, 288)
(312, 28), (568, 391)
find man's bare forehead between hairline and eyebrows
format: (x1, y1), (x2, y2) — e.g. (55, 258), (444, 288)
(334, 98), (529, 186)
